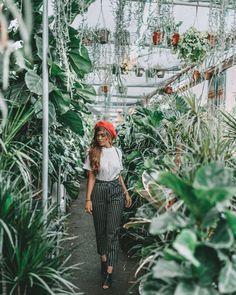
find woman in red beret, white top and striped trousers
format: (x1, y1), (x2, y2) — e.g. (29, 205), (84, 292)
(84, 121), (132, 289)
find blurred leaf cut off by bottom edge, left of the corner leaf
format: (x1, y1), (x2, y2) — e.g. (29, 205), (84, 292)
(174, 281), (219, 295)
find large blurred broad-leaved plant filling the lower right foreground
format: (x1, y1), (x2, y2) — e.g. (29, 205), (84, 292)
(141, 162), (236, 295)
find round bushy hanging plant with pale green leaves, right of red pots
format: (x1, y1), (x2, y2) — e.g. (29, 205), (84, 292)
(178, 27), (209, 63)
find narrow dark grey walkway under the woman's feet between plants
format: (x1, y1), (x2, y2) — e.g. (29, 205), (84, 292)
(68, 184), (139, 295)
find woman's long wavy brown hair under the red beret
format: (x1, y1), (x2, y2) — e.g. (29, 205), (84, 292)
(89, 127), (112, 175)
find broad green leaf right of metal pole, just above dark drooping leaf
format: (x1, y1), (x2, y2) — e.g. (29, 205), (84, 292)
(50, 89), (70, 114)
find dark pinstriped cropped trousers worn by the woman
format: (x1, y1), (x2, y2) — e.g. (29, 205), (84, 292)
(91, 179), (125, 266)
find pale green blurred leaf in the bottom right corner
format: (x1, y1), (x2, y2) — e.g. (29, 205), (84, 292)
(219, 260), (236, 294)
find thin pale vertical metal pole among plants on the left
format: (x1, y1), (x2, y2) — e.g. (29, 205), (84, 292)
(42, 0), (48, 216)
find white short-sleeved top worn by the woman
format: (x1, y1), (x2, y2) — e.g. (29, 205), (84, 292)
(83, 146), (123, 181)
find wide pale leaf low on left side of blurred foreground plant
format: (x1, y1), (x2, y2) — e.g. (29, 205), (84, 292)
(152, 259), (191, 279)
